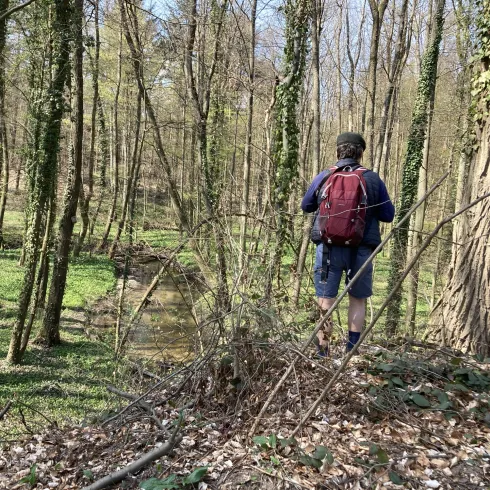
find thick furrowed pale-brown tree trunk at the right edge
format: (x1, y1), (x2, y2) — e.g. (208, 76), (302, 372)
(430, 0), (490, 357)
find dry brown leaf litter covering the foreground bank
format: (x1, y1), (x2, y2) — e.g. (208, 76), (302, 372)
(0, 345), (490, 490)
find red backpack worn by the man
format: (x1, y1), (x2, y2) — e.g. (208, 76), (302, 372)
(318, 166), (367, 247)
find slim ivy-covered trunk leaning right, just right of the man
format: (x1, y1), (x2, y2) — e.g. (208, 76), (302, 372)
(386, 0), (445, 335)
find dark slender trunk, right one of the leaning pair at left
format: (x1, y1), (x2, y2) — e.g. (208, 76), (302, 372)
(39, 0), (83, 346)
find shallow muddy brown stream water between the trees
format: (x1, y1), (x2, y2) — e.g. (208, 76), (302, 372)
(118, 261), (196, 361)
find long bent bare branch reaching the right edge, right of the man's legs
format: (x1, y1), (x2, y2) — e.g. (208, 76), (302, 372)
(291, 192), (490, 436)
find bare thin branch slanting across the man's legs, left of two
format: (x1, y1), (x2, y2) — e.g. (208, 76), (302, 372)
(248, 172), (449, 438)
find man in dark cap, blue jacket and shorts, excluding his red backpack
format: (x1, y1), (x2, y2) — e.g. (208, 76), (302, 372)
(301, 133), (395, 357)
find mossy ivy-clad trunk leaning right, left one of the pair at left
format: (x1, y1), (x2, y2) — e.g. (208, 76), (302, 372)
(7, 0), (71, 364)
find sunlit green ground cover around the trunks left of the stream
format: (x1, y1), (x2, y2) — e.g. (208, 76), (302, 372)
(0, 250), (118, 440)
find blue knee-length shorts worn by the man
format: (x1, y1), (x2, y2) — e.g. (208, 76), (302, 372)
(314, 243), (373, 299)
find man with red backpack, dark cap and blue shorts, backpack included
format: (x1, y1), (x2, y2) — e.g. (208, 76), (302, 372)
(301, 133), (395, 357)
